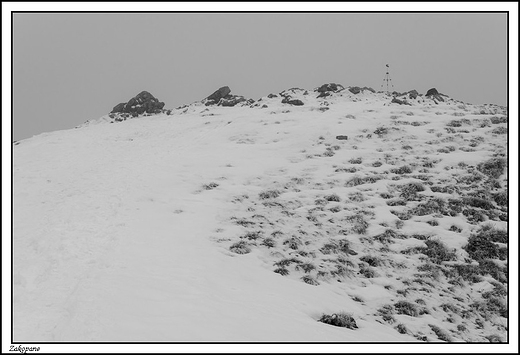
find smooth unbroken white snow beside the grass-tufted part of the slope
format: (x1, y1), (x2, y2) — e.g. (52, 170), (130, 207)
(13, 91), (508, 341)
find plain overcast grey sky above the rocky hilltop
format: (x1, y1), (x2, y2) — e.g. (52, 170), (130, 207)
(13, 13), (507, 140)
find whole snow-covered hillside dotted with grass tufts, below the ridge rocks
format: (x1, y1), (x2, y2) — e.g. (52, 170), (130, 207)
(13, 90), (507, 342)
